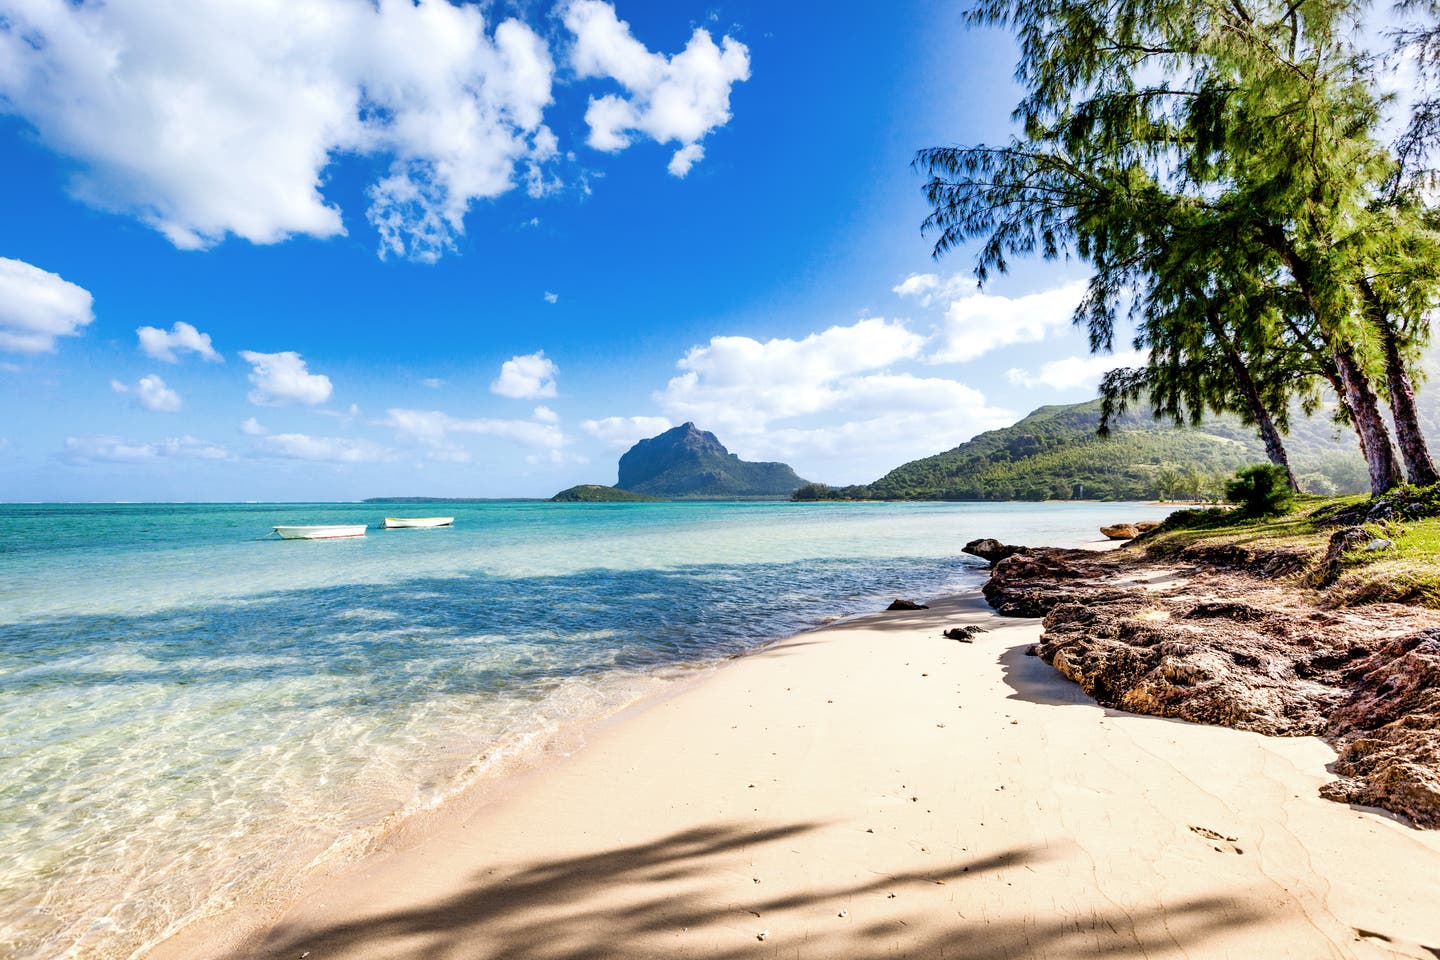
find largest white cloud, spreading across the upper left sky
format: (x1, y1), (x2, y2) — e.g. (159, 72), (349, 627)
(0, 0), (556, 261)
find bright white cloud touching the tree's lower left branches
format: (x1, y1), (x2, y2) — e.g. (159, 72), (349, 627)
(921, 281), (1086, 363)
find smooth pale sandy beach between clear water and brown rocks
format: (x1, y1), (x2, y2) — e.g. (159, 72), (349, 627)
(147, 597), (1440, 960)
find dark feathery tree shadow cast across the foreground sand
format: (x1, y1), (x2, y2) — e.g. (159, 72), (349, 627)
(241, 823), (1263, 960)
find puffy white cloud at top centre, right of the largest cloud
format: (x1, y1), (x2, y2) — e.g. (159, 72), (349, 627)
(563, 0), (750, 177)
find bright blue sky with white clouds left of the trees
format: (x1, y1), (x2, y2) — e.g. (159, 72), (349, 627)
(0, 0), (1110, 501)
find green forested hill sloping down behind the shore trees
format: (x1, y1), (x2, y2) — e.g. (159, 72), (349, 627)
(795, 400), (1368, 499)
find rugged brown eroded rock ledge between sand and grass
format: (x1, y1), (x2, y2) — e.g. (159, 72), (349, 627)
(985, 550), (1440, 828)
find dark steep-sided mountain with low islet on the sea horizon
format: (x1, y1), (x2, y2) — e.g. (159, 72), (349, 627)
(552, 423), (808, 502)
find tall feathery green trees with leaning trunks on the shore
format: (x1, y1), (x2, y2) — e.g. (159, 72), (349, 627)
(916, 0), (1440, 494)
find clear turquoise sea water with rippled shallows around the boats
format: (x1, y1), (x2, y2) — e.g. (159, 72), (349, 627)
(0, 502), (1166, 959)
